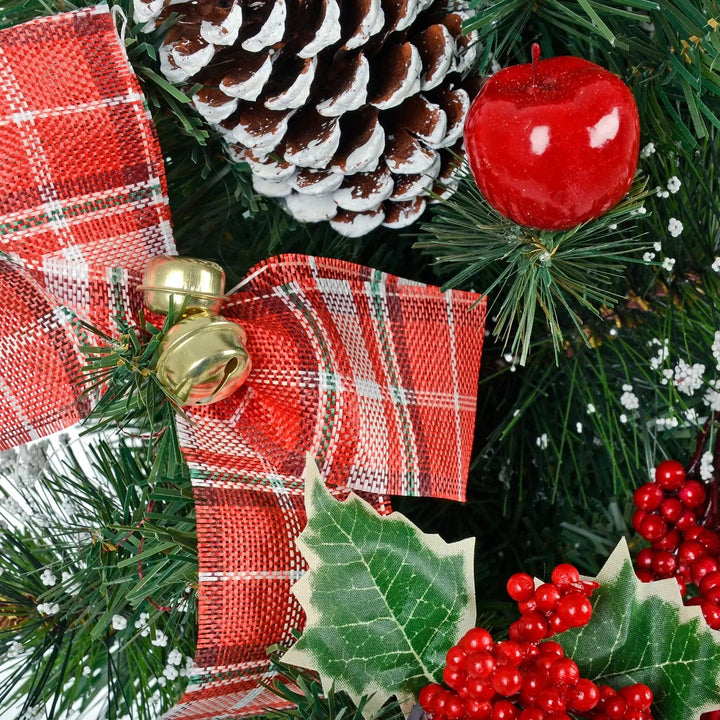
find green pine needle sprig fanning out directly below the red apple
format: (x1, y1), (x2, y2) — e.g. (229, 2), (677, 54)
(415, 168), (647, 365)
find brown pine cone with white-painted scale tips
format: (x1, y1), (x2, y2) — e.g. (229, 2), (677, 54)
(135, 0), (476, 237)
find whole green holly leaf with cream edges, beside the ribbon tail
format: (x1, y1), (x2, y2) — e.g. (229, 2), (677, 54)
(283, 458), (475, 717)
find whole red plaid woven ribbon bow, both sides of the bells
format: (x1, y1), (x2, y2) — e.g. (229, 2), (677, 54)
(0, 7), (485, 720)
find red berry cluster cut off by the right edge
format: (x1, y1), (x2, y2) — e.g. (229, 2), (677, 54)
(633, 460), (720, 630)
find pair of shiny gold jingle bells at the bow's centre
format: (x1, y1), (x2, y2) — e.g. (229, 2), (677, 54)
(140, 255), (252, 405)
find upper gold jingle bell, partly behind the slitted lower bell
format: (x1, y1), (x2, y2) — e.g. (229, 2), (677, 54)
(139, 255), (225, 316)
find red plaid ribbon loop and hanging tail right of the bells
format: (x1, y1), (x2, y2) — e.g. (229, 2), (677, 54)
(166, 256), (485, 720)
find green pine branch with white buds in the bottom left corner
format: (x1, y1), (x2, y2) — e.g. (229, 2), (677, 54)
(0, 441), (197, 720)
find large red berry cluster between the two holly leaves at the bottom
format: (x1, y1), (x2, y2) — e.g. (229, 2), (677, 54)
(419, 565), (652, 720)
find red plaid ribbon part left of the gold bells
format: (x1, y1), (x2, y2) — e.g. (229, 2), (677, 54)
(0, 7), (175, 449)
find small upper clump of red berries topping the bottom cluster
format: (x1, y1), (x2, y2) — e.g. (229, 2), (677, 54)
(507, 564), (600, 642)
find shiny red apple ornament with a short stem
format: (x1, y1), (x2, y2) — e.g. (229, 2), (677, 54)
(465, 44), (640, 230)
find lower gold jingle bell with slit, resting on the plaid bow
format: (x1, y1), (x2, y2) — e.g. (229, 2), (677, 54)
(156, 314), (251, 405)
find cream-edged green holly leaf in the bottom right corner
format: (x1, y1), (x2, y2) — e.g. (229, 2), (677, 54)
(553, 539), (720, 720)
